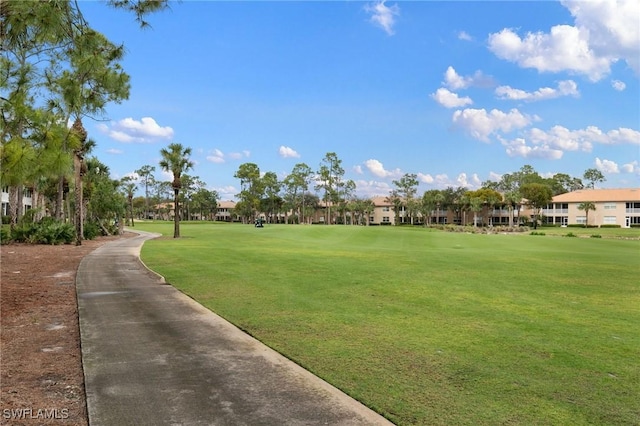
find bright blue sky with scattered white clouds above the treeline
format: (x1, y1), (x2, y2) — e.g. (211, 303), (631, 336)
(81, 0), (640, 200)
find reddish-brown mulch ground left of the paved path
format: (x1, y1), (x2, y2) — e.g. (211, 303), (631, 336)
(0, 233), (135, 426)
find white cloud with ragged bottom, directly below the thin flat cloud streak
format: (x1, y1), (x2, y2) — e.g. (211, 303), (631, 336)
(453, 108), (537, 142)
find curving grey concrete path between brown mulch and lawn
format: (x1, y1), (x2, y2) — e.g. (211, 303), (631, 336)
(76, 233), (391, 426)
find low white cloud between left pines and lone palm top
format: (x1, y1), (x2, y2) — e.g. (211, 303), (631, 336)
(97, 117), (173, 143)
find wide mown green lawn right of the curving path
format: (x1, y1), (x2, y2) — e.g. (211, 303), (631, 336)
(136, 222), (640, 425)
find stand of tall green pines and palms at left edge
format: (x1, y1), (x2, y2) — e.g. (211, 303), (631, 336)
(0, 0), (167, 244)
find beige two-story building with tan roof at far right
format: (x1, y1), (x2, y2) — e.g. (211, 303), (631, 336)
(542, 188), (640, 228)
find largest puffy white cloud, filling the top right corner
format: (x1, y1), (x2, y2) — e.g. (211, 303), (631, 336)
(489, 0), (640, 81)
